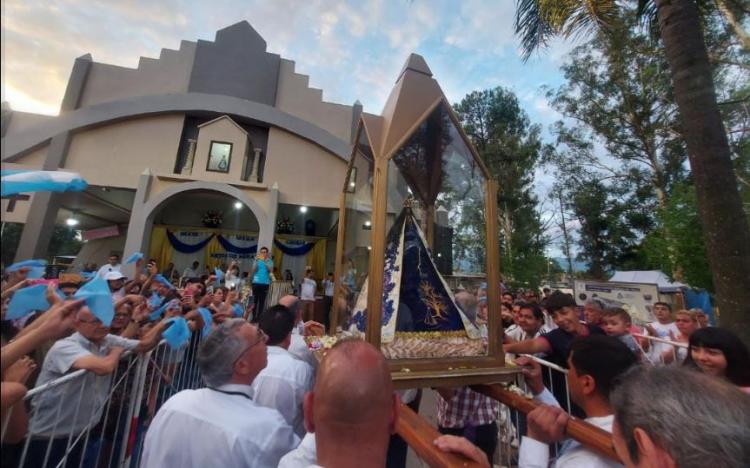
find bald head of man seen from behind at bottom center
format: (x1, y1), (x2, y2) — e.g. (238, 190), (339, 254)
(304, 340), (400, 468)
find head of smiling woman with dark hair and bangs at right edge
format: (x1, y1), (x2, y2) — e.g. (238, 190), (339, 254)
(684, 327), (750, 393)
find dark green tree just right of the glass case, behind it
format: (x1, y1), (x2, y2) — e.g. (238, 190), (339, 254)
(454, 87), (548, 287)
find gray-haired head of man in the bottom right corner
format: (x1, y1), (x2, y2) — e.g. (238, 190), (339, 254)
(610, 366), (750, 468)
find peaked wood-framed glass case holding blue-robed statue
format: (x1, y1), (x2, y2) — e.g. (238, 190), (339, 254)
(331, 55), (512, 387)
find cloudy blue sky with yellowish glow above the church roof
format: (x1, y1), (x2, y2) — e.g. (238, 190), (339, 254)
(2, 0), (572, 254)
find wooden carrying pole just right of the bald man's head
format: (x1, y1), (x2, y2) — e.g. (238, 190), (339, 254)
(396, 404), (482, 468)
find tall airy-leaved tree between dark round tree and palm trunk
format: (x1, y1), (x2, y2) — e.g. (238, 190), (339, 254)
(547, 11), (685, 277)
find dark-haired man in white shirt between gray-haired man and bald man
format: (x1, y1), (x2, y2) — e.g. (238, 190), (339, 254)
(252, 304), (315, 437)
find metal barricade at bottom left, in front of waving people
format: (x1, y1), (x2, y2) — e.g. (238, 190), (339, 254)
(2, 331), (203, 468)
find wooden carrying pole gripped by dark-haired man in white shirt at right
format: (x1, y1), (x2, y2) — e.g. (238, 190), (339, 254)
(471, 385), (622, 463)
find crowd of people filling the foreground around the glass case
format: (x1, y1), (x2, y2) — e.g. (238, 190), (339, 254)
(2, 254), (750, 468)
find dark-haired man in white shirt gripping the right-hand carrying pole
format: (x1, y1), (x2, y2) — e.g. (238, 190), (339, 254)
(516, 335), (637, 468)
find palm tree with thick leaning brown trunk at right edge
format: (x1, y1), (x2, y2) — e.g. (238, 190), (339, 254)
(516, 0), (750, 344)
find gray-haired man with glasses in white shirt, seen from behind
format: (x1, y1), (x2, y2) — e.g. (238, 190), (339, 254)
(141, 318), (299, 468)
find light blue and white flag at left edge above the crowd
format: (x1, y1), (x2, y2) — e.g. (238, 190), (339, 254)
(0, 169), (88, 197)
